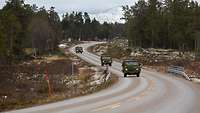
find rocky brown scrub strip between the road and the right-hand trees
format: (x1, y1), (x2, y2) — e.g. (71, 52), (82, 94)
(89, 40), (200, 78)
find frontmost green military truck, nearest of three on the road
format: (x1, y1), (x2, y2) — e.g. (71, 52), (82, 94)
(122, 59), (141, 77)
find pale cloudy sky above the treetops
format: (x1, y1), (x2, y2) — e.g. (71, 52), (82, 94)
(0, 0), (136, 23)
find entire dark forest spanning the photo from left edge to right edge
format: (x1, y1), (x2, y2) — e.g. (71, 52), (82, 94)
(0, 0), (200, 64)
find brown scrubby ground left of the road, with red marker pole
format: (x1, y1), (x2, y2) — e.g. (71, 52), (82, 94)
(0, 44), (118, 112)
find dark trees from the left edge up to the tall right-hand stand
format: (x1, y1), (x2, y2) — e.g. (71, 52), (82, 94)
(0, 0), (123, 64)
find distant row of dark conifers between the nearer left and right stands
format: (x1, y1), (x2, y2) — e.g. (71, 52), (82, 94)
(62, 12), (124, 40)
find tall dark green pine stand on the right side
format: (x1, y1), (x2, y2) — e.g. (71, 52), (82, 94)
(123, 0), (200, 50)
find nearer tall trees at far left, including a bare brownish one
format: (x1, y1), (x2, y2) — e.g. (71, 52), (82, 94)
(0, 0), (61, 64)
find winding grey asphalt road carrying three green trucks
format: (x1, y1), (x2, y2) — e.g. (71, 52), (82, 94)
(7, 42), (200, 113)
